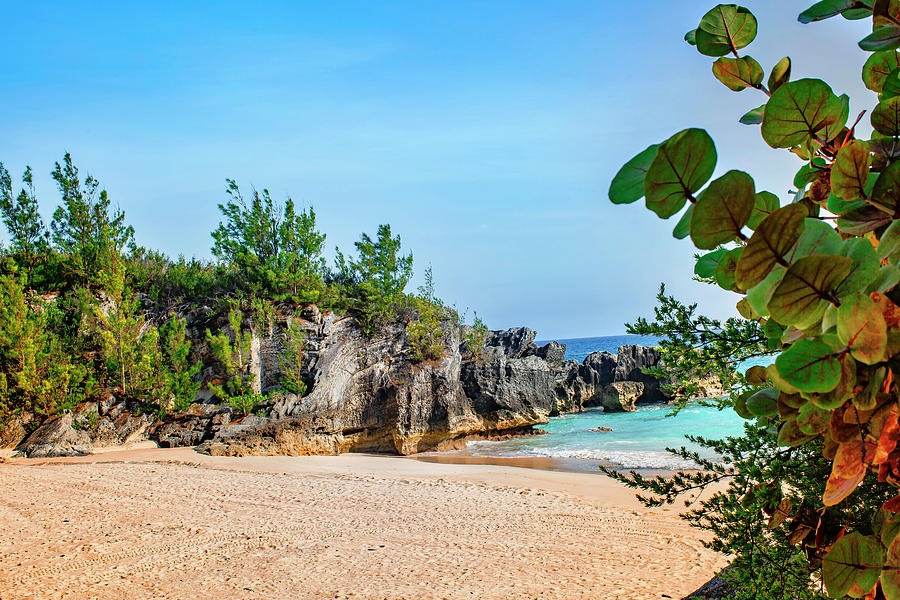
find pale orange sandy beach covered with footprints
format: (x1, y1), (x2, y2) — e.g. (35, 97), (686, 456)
(0, 448), (724, 600)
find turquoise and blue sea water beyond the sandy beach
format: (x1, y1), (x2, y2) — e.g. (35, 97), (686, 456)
(442, 335), (764, 470)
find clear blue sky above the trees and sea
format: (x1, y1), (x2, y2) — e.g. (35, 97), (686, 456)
(0, 0), (874, 338)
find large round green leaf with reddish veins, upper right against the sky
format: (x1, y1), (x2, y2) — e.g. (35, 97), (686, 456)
(762, 79), (847, 148)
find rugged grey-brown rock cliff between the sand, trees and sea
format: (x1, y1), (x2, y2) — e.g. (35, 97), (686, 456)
(0, 305), (721, 456)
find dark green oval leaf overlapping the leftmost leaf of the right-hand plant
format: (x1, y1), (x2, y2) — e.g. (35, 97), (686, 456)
(644, 129), (717, 219)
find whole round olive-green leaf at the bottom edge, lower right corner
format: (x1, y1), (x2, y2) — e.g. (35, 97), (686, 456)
(822, 532), (882, 598)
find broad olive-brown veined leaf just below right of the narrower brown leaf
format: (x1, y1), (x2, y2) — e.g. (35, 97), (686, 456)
(767, 254), (853, 329)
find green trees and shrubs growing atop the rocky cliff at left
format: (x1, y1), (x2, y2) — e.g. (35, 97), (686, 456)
(0, 154), (456, 426)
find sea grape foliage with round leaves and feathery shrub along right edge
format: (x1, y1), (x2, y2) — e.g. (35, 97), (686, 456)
(607, 0), (900, 600)
